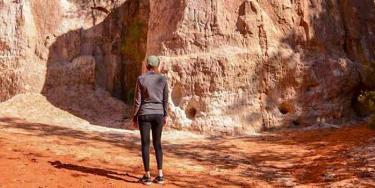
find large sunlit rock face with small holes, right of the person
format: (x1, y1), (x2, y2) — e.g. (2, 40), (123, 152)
(148, 0), (375, 133)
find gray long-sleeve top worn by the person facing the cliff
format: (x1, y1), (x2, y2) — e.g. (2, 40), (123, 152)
(133, 71), (168, 117)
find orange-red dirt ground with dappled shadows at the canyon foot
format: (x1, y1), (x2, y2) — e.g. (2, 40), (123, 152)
(0, 118), (375, 188)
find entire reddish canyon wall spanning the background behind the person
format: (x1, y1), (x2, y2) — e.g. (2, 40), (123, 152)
(0, 0), (375, 134)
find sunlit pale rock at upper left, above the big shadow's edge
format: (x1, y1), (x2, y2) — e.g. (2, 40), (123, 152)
(0, 0), (124, 101)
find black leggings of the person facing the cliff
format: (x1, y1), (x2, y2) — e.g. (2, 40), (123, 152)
(138, 114), (163, 171)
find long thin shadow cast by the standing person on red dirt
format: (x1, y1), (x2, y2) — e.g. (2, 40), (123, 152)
(49, 161), (139, 183)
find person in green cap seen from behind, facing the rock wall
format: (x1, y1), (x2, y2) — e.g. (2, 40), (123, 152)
(133, 56), (168, 185)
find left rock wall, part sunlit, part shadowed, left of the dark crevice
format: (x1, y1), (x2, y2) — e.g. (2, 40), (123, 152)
(0, 0), (127, 127)
